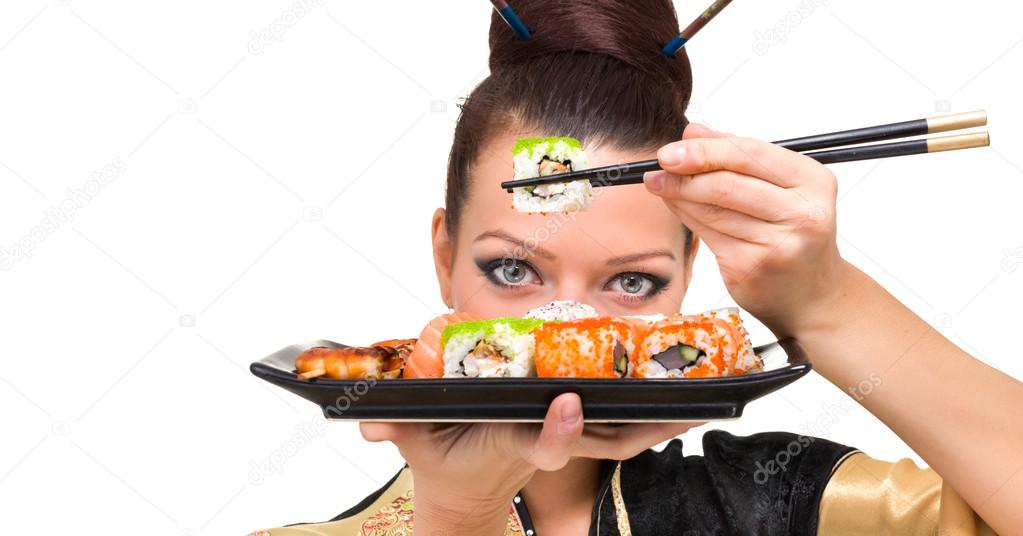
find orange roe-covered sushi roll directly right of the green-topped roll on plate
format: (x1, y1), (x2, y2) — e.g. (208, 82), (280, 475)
(533, 316), (646, 378)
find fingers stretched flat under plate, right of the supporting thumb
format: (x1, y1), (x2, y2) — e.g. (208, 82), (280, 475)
(575, 422), (702, 459)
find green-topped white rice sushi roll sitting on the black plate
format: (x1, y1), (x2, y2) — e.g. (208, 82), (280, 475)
(441, 317), (543, 377)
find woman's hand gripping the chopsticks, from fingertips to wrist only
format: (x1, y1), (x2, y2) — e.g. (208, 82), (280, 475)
(646, 124), (846, 337)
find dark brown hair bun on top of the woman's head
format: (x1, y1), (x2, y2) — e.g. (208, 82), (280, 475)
(490, 0), (692, 83)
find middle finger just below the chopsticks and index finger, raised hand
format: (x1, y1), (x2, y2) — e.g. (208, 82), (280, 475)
(644, 171), (809, 222)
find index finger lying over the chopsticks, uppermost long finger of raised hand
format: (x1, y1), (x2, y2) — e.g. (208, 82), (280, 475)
(657, 136), (820, 188)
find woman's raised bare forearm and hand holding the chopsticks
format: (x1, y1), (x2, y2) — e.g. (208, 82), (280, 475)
(646, 125), (1023, 534)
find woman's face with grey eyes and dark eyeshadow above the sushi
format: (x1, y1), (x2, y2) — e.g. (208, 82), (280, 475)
(433, 129), (696, 318)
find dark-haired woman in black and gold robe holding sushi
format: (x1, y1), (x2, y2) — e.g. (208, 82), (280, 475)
(253, 0), (1023, 536)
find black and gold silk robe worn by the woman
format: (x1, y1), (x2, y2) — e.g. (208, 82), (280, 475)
(252, 431), (993, 536)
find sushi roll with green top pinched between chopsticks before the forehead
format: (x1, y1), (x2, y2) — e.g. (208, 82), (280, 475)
(512, 138), (593, 213)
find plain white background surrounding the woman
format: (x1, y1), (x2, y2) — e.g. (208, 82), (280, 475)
(0, 0), (1023, 535)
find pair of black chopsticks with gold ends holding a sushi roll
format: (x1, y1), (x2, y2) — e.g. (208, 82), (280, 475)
(501, 110), (990, 191)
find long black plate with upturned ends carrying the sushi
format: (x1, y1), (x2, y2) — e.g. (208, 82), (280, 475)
(250, 340), (810, 422)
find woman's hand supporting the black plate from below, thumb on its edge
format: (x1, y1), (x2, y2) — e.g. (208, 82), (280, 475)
(360, 393), (697, 535)
